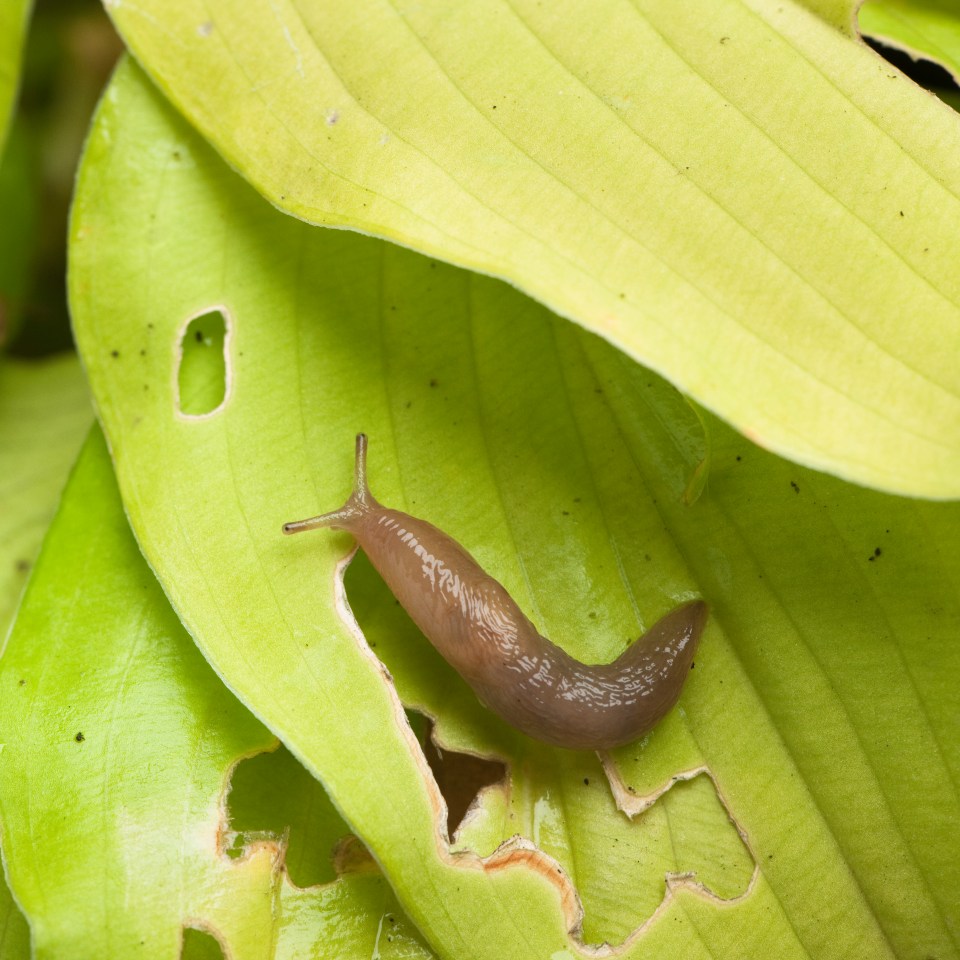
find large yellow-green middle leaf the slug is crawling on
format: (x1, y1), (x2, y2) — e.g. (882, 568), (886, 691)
(71, 58), (960, 960)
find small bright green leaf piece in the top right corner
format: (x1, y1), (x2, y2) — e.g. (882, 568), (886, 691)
(859, 0), (960, 79)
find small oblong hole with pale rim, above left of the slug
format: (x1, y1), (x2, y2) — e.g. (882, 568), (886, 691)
(177, 310), (230, 417)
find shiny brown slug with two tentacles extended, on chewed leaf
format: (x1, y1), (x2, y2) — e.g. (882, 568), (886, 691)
(283, 433), (707, 750)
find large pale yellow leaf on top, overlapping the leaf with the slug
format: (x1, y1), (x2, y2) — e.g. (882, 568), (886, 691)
(99, 0), (960, 497)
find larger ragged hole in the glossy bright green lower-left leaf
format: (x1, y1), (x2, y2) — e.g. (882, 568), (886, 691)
(226, 746), (350, 887)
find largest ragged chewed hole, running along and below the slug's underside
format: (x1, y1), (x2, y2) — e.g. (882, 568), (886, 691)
(344, 532), (755, 945)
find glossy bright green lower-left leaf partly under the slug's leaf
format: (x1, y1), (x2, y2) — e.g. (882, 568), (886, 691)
(0, 431), (429, 960)
